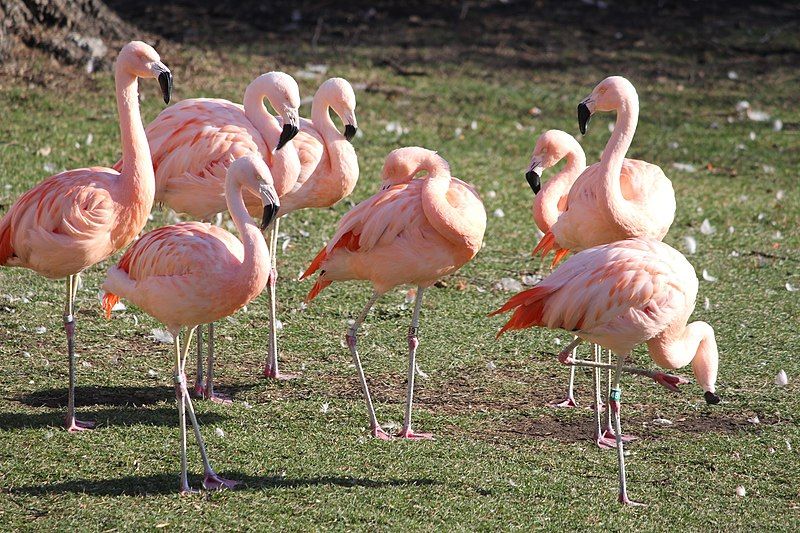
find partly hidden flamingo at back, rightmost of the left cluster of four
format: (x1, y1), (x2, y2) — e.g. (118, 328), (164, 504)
(264, 78), (358, 379)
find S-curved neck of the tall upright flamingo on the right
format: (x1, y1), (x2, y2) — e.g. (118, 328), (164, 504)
(599, 93), (639, 228)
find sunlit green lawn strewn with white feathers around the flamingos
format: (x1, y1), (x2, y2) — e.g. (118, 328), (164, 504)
(0, 4), (800, 530)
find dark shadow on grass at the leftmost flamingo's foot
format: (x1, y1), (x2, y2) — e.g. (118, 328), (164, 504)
(0, 407), (227, 431)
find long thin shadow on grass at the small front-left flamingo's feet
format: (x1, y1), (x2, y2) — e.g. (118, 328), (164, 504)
(12, 472), (437, 496)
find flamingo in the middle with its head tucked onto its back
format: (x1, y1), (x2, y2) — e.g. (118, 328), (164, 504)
(301, 147), (486, 440)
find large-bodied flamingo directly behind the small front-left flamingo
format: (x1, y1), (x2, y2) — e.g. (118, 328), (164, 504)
(122, 72), (301, 394)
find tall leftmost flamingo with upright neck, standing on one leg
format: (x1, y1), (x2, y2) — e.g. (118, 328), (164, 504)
(0, 41), (172, 432)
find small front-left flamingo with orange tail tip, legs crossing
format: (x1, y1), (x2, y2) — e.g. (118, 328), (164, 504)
(103, 154), (279, 493)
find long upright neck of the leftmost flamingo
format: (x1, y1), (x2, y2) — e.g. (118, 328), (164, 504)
(114, 63), (155, 195)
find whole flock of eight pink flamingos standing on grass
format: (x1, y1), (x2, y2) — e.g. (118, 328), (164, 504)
(0, 42), (720, 504)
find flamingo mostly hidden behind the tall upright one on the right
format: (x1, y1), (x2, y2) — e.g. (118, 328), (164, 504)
(525, 130), (586, 407)
